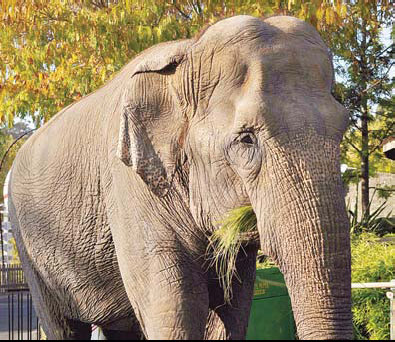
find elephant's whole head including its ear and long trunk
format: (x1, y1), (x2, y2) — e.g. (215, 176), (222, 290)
(118, 16), (352, 339)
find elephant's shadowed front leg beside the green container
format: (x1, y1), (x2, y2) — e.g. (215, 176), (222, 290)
(209, 246), (257, 340)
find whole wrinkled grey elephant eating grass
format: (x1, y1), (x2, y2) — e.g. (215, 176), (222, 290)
(10, 16), (352, 339)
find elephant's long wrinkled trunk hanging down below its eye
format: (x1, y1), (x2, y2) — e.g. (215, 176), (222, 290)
(258, 131), (352, 339)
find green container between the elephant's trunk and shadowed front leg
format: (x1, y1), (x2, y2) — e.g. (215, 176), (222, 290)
(247, 268), (296, 340)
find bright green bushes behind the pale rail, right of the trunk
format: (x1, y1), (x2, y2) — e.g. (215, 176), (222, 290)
(352, 233), (395, 340)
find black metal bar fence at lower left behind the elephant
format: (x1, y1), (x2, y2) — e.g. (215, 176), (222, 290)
(0, 265), (41, 340)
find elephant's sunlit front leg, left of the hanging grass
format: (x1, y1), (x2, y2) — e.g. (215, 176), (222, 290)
(127, 253), (209, 340)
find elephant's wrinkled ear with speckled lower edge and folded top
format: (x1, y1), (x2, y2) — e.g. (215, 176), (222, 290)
(117, 41), (189, 197)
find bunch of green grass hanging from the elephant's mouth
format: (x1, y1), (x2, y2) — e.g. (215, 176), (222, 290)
(207, 206), (257, 303)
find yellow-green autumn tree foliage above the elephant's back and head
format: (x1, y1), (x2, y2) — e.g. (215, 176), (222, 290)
(0, 0), (352, 125)
